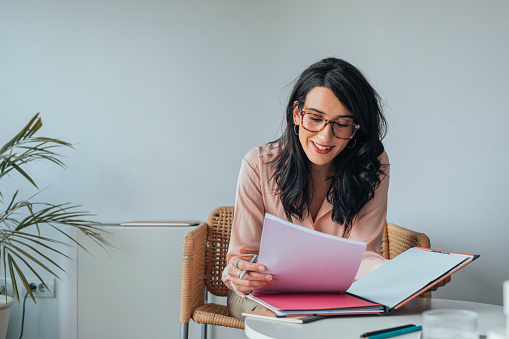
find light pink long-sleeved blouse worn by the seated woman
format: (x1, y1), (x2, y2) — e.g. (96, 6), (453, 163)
(223, 145), (389, 288)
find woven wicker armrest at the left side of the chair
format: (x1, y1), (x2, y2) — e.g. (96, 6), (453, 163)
(180, 223), (207, 323)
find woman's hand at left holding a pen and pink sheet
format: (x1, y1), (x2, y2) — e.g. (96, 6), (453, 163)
(228, 256), (274, 294)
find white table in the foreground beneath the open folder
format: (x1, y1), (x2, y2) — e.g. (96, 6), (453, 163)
(245, 298), (505, 339)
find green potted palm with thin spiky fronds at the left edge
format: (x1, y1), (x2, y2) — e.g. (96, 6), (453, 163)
(0, 113), (110, 338)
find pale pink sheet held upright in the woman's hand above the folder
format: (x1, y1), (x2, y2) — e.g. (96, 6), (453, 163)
(255, 213), (366, 293)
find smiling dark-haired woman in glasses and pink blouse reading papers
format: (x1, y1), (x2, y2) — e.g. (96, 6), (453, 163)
(223, 58), (389, 319)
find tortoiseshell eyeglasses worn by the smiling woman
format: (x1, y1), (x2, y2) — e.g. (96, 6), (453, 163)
(300, 110), (361, 140)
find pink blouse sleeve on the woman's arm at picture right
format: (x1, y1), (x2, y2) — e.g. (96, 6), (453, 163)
(354, 152), (389, 279)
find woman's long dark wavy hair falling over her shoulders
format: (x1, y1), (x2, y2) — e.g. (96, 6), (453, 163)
(271, 58), (387, 237)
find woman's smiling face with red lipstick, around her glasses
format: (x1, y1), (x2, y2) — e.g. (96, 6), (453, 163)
(293, 86), (354, 171)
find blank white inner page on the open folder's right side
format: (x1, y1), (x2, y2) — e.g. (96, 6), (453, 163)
(348, 248), (472, 308)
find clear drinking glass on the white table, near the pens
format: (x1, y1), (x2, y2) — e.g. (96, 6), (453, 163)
(422, 310), (479, 339)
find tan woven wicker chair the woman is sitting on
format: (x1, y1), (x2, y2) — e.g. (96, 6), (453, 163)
(180, 206), (430, 339)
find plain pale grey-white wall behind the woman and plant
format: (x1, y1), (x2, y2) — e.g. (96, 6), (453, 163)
(0, 0), (509, 338)
